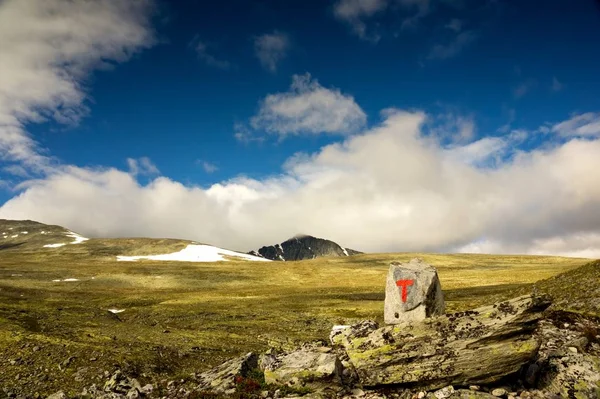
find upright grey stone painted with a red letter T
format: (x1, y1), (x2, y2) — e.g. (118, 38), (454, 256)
(384, 258), (445, 324)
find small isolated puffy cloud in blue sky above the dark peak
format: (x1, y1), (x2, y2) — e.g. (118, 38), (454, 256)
(250, 73), (367, 136)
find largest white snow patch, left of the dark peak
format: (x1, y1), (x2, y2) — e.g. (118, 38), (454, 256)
(117, 245), (270, 262)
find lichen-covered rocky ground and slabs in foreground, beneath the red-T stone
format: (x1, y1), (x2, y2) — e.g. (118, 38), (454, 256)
(34, 296), (600, 399)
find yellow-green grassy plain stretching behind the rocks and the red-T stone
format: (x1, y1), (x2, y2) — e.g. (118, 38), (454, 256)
(0, 220), (589, 396)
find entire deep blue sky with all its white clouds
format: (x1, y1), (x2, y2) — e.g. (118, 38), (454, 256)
(0, 0), (600, 258)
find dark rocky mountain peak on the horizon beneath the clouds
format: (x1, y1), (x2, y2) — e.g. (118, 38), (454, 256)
(249, 235), (362, 261)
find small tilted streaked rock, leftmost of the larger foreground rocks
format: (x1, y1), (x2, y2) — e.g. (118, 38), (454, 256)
(197, 352), (258, 394)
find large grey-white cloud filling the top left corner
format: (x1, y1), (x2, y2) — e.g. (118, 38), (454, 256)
(0, 0), (153, 173)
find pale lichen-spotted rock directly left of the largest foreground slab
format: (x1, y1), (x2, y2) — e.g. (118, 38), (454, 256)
(264, 348), (343, 388)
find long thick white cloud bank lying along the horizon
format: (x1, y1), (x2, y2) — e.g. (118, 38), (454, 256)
(0, 110), (600, 256)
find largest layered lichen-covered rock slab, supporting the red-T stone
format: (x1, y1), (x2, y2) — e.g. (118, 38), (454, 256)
(337, 296), (550, 390)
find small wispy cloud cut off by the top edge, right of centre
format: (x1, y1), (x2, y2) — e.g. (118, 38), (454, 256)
(333, 0), (388, 42)
